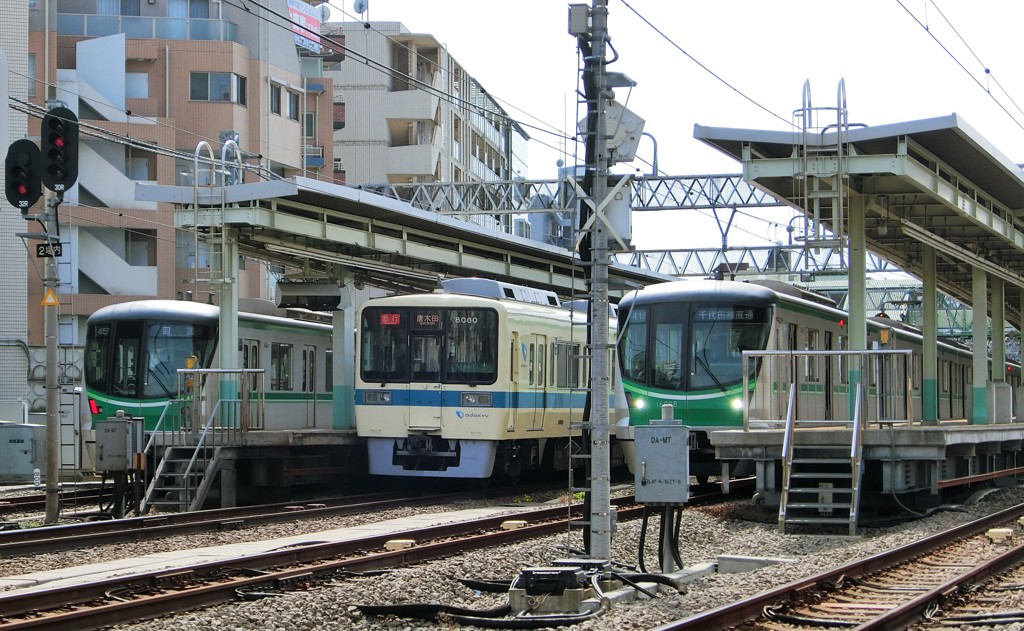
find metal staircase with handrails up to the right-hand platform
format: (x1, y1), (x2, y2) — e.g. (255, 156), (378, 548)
(778, 384), (862, 537)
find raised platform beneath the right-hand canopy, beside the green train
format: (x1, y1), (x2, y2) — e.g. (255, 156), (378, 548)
(709, 420), (1024, 506)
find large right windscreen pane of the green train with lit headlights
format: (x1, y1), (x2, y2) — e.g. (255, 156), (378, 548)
(687, 304), (769, 389)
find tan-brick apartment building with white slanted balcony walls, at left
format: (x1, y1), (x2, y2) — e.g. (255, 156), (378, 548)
(14, 0), (333, 410)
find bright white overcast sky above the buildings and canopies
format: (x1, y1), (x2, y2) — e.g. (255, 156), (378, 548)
(321, 0), (1024, 249)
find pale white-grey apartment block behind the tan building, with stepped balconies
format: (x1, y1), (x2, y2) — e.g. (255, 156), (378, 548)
(322, 22), (529, 190)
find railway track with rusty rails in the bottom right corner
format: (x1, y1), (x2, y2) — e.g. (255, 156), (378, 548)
(657, 504), (1024, 631)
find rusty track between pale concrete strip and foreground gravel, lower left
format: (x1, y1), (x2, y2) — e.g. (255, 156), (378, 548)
(0, 498), (643, 631)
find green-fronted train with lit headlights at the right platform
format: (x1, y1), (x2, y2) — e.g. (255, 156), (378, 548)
(616, 281), (1021, 479)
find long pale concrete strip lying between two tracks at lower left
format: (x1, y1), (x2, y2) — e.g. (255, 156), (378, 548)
(0, 505), (537, 593)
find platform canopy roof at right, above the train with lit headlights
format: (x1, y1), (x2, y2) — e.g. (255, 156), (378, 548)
(693, 114), (1024, 328)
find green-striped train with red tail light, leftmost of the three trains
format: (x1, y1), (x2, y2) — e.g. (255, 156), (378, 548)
(85, 300), (333, 431)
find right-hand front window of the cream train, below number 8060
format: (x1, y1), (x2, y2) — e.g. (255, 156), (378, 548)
(443, 308), (498, 384)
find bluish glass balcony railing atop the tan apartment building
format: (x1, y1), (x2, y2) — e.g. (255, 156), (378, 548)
(57, 13), (239, 42)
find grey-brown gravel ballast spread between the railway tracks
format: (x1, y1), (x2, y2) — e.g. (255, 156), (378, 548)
(8, 488), (1024, 631)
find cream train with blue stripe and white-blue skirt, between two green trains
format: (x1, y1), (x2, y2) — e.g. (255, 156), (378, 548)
(355, 279), (602, 480)
